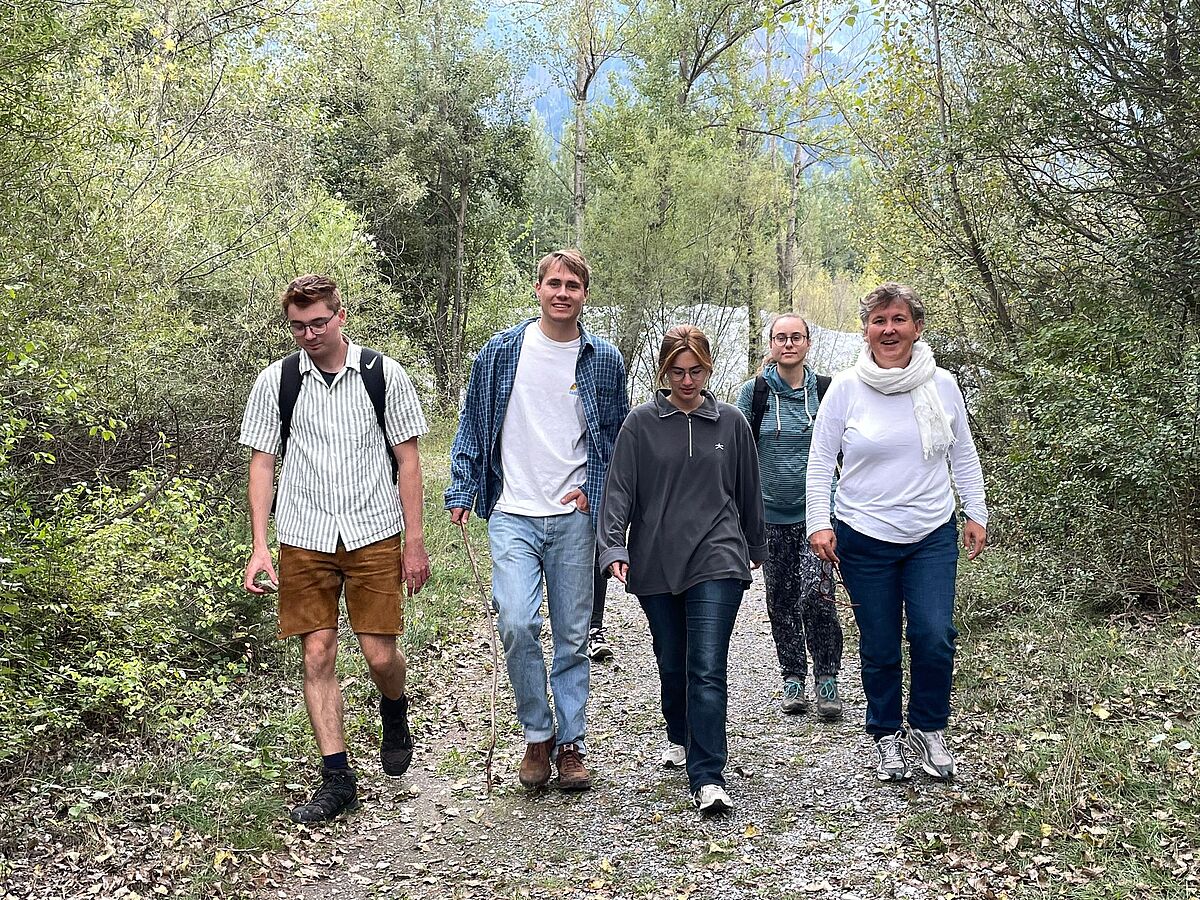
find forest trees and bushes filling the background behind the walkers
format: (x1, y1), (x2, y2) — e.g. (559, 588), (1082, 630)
(0, 0), (1200, 764)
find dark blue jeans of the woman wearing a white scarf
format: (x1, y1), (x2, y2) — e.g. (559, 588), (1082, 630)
(834, 518), (959, 736)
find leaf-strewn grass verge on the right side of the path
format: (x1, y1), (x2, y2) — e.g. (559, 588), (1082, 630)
(901, 551), (1200, 898)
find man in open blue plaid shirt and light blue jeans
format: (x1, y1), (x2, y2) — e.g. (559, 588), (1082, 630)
(445, 250), (629, 791)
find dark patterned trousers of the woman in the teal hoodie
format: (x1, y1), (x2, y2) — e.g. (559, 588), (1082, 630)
(762, 522), (842, 682)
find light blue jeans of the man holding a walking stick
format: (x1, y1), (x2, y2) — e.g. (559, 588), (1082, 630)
(487, 510), (595, 751)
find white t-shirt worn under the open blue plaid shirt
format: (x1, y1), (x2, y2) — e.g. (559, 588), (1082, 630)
(496, 322), (588, 516)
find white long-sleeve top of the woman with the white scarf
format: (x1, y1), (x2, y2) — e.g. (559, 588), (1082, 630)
(806, 368), (988, 544)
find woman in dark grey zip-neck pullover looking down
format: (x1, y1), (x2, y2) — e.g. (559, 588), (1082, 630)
(596, 325), (767, 812)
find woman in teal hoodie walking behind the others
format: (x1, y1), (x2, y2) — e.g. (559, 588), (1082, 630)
(738, 313), (842, 720)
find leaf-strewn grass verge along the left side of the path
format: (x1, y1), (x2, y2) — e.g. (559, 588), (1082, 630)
(0, 424), (490, 898)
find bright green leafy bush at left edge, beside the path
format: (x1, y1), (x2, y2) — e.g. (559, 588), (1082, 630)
(0, 472), (269, 764)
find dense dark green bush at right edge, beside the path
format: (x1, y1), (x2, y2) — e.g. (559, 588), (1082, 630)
(991, 310), (1200, 606)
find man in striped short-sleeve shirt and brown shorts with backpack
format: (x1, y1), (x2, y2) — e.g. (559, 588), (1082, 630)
(241, 275), (430, 822)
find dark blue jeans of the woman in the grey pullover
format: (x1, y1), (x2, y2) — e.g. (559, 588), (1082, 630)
(638, 578), (742, 791)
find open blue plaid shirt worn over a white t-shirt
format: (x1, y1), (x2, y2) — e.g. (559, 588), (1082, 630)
(445, 318), (629, 526)
